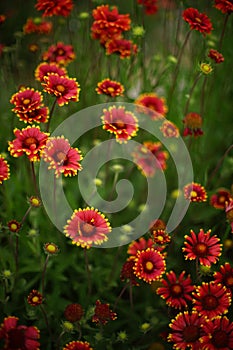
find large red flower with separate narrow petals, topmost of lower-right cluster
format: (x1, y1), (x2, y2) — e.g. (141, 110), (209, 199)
(182, 229), (222, 266)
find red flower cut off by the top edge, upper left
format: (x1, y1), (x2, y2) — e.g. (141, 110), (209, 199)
(35, 0), (74, 17)
